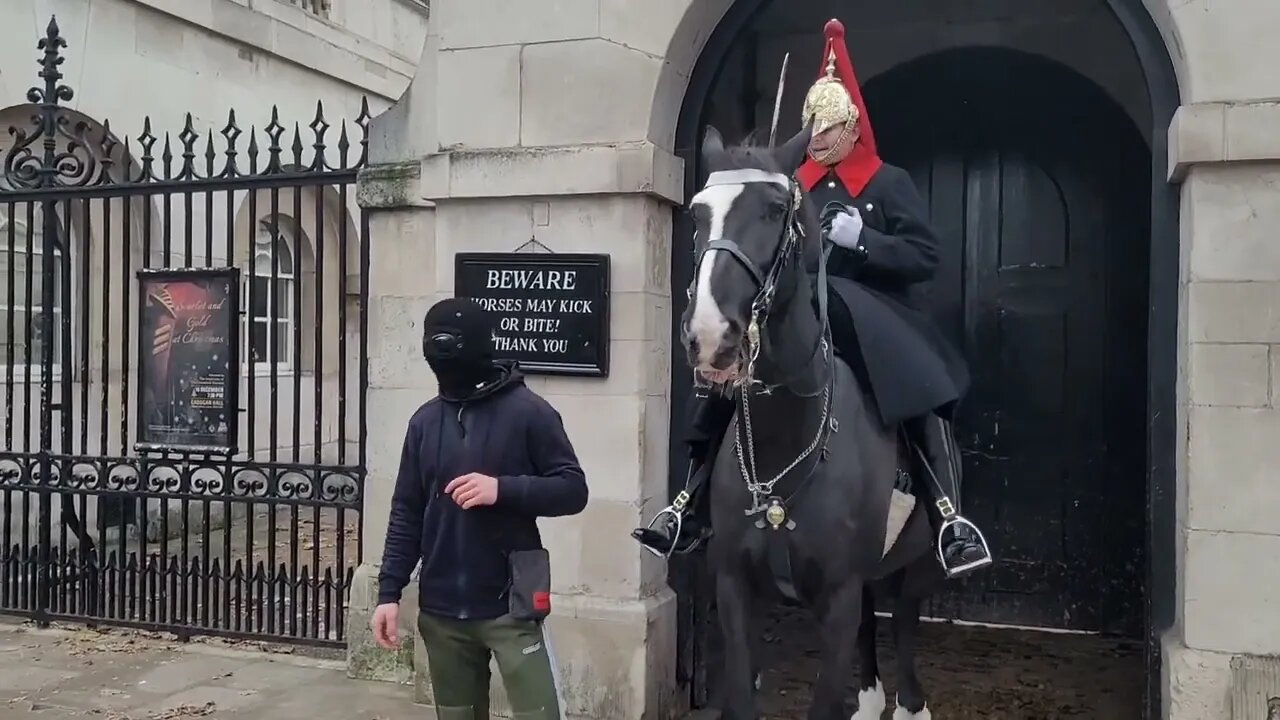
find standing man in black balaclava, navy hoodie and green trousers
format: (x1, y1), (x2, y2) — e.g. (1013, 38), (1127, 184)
(370, 299), (588, 720)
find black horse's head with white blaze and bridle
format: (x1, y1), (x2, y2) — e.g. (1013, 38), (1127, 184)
(682, 127), (810, 384)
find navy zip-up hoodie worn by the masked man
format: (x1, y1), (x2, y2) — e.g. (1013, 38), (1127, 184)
(378, 365), (588, 619)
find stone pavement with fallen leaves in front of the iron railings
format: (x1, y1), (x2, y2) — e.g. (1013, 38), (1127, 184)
(0, 621), (434, 720)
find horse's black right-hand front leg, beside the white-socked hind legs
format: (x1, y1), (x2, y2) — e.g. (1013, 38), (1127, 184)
(809, 577), (863, 720)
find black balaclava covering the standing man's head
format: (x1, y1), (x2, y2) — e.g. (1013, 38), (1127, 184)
(422, 297), (495, 400)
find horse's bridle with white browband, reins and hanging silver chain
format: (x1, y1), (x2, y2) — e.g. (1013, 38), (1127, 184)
(687, 169), (837, 520)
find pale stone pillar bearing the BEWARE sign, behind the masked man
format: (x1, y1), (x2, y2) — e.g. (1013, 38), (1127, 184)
(407, 142), (680, 719)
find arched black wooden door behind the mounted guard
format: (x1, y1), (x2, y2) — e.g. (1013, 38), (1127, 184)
(868, 50), (1149, 634)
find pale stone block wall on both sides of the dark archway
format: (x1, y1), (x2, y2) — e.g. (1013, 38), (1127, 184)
(351, 0), (1280, 720)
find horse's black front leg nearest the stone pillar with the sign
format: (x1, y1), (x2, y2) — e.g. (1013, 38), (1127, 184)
(716, 569), (759, 720)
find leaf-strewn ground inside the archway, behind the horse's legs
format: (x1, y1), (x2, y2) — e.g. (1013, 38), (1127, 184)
(759, 609), (1143, 720)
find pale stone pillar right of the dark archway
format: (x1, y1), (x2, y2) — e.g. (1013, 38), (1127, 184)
(1164, 102), (1280, 720)
